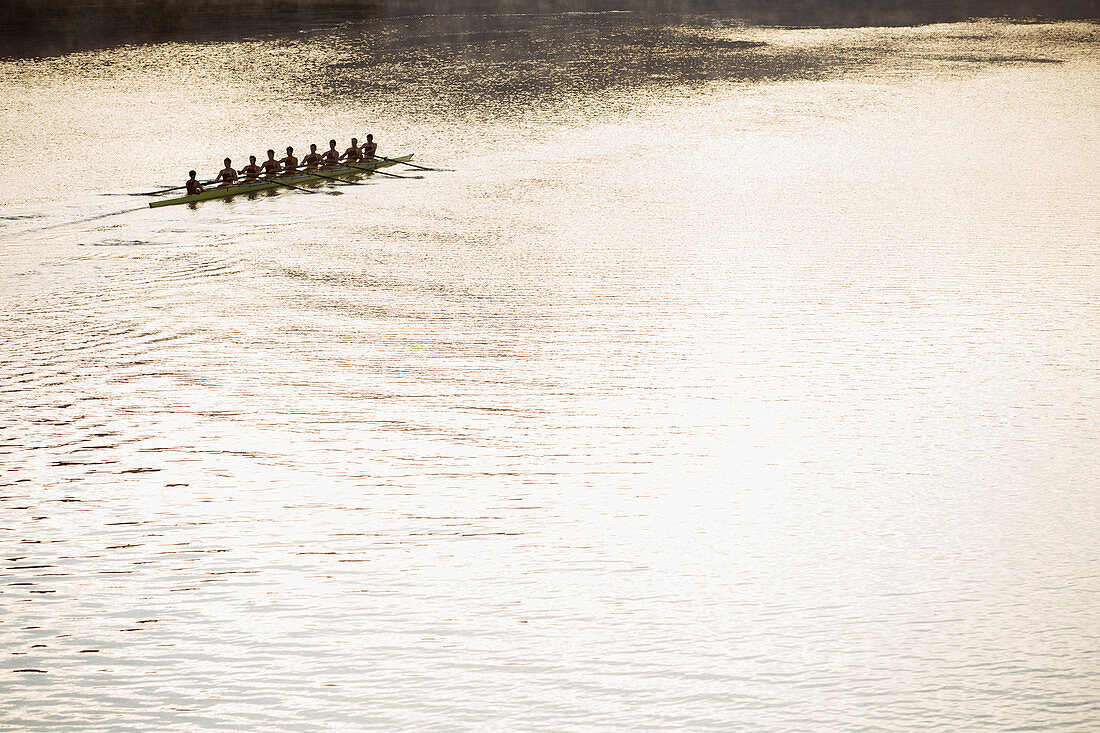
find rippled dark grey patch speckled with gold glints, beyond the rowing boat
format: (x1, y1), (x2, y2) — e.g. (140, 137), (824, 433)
(301, 13), (902, 107)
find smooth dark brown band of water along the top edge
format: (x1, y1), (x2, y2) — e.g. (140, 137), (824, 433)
(0, 0), (1100, 58)
